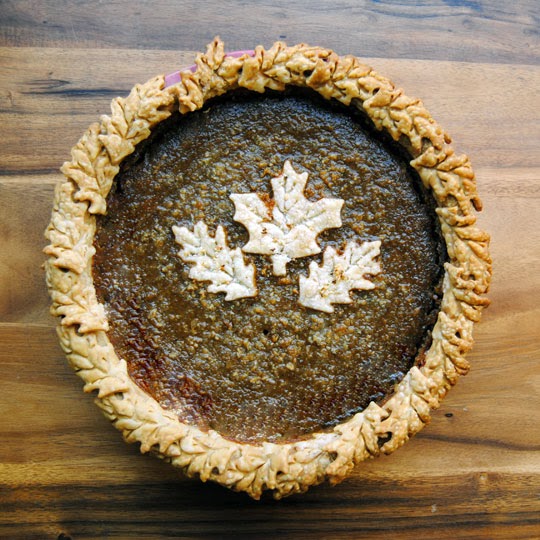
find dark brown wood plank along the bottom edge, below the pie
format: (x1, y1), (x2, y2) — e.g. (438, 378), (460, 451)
(0, 474), (540, 540)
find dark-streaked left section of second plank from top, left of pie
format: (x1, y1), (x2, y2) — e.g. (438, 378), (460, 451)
(0, 48), (195, 175)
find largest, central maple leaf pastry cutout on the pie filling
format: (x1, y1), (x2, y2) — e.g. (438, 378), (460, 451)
(230, 160), (344, 276)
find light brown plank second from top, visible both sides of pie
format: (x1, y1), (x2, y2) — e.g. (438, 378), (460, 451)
(0, 48), (540, 175)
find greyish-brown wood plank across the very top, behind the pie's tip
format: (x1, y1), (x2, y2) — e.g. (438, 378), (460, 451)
(0, 0), (539, 64)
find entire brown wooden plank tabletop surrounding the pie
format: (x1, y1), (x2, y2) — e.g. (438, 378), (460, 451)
(0, 0), (540, 539)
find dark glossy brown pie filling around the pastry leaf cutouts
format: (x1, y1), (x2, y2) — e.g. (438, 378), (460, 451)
(93, 90), (446, 443)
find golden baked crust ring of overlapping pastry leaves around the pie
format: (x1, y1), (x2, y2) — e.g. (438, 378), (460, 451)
(45, 38), (491, 499)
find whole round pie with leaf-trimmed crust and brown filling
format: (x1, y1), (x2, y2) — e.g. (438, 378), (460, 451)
(45, 38), (491, 499)
